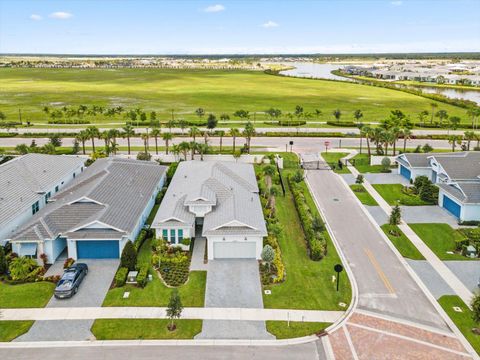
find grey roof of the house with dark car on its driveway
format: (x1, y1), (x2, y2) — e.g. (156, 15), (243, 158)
(12, 158), (167, 241)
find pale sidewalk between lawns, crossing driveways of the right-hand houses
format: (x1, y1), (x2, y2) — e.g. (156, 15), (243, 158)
(348, 161), (473, 306)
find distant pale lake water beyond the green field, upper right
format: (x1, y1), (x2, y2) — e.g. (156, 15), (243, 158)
(280, 62), (480, 105)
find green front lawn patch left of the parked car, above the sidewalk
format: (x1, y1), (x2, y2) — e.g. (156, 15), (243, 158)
(0, 281), (55, 308)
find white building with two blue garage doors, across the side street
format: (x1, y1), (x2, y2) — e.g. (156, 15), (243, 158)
(397, 151), (480, 221)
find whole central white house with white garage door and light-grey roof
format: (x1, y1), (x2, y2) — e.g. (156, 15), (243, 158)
(152, 161), (267, 260)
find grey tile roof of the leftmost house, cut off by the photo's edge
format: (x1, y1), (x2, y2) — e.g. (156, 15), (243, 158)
(0, 154), (85, 226)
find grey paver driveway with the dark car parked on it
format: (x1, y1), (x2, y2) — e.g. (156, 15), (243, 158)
(15, 259), (119, 341)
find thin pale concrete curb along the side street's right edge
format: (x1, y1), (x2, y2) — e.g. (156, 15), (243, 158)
(336, 158), (480, 359)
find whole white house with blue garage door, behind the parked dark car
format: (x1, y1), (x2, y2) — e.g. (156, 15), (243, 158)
(10, 158), (166, 263)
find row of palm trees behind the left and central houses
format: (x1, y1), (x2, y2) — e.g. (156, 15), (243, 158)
(75, 122), (255, 155)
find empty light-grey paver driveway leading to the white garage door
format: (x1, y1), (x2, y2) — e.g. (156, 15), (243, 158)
(196, 259), (274, 339)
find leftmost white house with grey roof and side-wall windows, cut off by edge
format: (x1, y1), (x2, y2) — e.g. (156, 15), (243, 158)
(0, 154), (85, 245)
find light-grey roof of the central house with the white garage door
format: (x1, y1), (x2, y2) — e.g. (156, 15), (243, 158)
(152, 161), (267, 236)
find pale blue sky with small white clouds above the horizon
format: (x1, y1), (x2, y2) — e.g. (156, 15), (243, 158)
(0, 0), (480, 54)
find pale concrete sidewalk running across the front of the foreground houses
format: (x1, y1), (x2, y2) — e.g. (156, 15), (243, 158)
(0, 307), (345, 323)
